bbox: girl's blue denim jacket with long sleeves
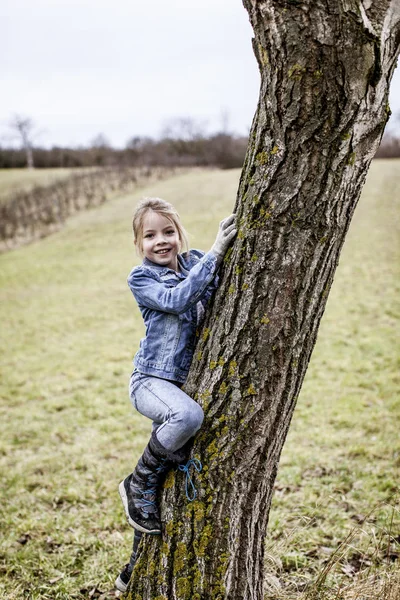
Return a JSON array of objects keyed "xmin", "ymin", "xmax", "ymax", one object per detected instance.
[{"xmin": 128, "ymin": 250, "xmax": 218, "ymax": 383}]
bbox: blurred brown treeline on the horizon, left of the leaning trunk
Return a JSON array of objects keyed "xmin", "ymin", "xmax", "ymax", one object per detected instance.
[{"xmin": 0, "ymin": 133, "xmax": 248, "ymax": 169}]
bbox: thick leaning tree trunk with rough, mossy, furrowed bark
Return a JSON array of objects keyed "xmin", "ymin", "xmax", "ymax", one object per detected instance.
[{"xmin": 129, "ymin": 0, "xmax": 400, "ymax": 600}]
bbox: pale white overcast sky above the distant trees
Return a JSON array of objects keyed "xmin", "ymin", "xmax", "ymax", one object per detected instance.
[{"xmin": 0, "ymin": 0, "xmax": 400, "ymax": 146}]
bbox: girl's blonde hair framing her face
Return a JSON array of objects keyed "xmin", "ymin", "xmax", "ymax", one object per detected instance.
[{"xmin": 132, "ymin": 198, "xmax": 189, "ymax": 256}]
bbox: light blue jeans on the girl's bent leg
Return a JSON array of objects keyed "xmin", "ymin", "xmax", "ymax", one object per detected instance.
[{"xmin": 129, "ymin": 371, "xmax": 204, "ymax": 452}]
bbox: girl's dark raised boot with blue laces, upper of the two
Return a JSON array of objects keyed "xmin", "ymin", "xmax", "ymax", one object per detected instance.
[{"xmin": 119, "ymin": 432, "xmax": 187, "ymax": 535}]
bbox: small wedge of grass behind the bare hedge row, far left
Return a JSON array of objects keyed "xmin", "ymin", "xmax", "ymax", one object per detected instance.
[{"xmin": 0, "ymin": 168, "xmax": 83, "ymax": 202}]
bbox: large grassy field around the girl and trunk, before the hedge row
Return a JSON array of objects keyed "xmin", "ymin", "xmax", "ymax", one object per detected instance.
[{"xmin": 0, "ymin": 160, "xmax": 400, "ymax": 600}]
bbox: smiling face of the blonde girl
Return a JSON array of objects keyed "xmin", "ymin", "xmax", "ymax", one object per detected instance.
[{"xmin": 142, "ymin": 210, "xmax": 181, "ymax": 271}]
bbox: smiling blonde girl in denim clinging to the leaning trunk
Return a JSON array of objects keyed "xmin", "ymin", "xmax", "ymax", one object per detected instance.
[{"xmin": 116, "ymin": 198, "xmax": 236, "ymax": 591}]
